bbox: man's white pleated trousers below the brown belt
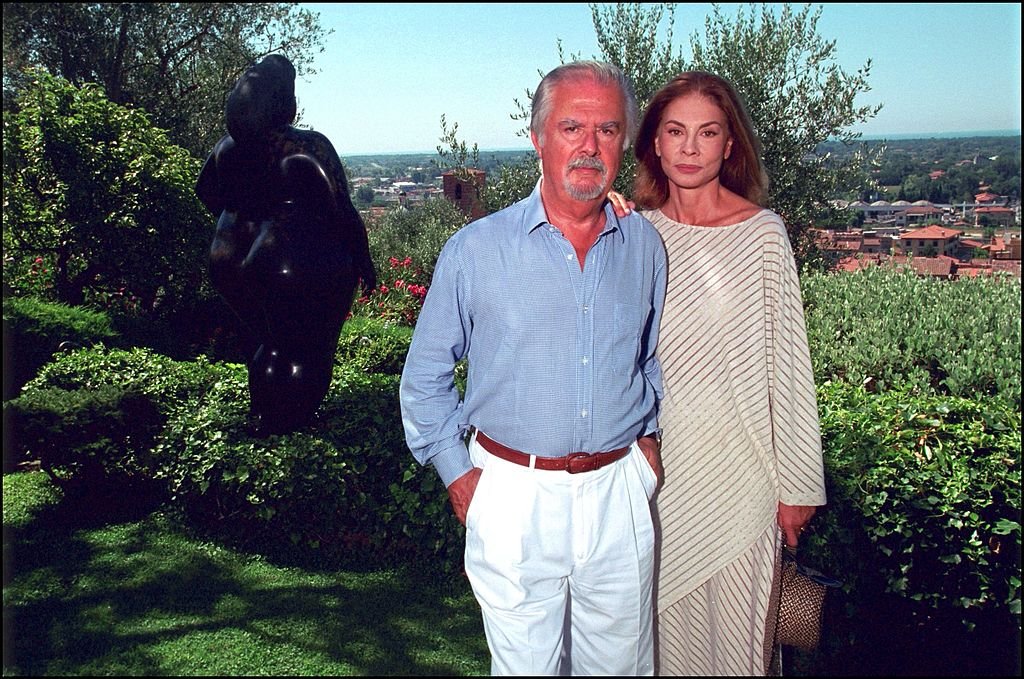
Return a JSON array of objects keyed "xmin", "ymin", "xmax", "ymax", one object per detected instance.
[{"xmin": 466, "ymin": 436, "xmax": 657, "ymax": 676}]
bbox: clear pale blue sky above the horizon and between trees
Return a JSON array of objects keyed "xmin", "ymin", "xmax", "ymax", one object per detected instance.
[{"xmin": 296, "ymin": 3, "xmax": 1021, "ymax": 157}]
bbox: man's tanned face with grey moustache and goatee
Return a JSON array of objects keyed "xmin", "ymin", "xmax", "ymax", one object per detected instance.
[{"xmin": 530, "ymin": 78, "xmax": 626, "ymax": 201}]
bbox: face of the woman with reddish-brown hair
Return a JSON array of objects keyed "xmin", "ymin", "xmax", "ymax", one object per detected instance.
[{"xmin": 654, "ymin": 93, "xmax": 732, "ymax": 188}]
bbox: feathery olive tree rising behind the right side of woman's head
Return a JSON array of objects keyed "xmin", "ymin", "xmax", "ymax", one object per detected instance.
[{"xmin": 687, "ymin": 4, "xmax": 882, "ymax": 260}]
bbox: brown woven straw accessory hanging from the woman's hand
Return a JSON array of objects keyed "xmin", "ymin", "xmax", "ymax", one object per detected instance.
[{"xmin": 775, "ymin": 545, "xmax": 842, "ymax": 650}]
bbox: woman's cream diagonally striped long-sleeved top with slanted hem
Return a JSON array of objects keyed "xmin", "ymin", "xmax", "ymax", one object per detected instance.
[{"xmin": 643, "ymin": 210, "xmax": 825, "ymax": 610}]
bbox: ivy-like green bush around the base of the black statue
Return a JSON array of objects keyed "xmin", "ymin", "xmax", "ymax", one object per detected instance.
[{"xmin": 14, "ymin": 348, "xmax": 463, "ymax": 572}]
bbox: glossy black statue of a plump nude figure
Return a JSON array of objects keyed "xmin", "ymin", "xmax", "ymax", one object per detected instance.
[{"xmin": 196, "ymin": 54, "xmax": 377, "ymax": 435}]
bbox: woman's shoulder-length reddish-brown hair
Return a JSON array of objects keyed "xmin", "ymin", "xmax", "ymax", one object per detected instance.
[{"xmin": 633, "ymin": 71, "xmax": 768, "ymax": 208}]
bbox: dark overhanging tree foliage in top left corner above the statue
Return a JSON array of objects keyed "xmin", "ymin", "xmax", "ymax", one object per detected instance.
[{"xmin": 3, "ymin": 2, "xmax": 325, "ymax": 158}]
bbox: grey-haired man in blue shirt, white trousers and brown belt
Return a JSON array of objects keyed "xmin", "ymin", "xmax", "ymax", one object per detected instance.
[{"xmin": 401, "ymin": 61, "xmax": 666, "ymax": 675}]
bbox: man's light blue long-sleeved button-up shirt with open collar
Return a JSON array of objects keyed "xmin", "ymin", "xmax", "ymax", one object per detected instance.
[{"xmin": 400, "ymin": 182, "xmax": 667, "ymax": 485}]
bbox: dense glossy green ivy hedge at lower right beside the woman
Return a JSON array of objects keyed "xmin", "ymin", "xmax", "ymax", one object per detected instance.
[{"xmin": 809, "ymin": 382, "xmax": 1021, "ymax": 628}]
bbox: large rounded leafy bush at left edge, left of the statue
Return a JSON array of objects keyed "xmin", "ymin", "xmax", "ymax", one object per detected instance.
[{"xmin": 3, "ymin": 66, "xmax": 210, "ymax": 312}]
